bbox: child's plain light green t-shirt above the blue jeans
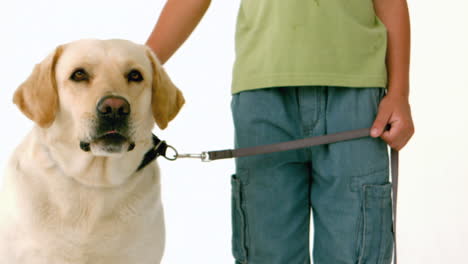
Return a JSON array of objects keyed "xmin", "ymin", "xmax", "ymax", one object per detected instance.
[{"xmin": 232, "ymin": 0, "xmax": 387, "ymax": 93}]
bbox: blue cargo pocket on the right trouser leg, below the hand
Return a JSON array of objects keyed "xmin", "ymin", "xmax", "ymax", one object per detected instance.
[{"xmin": 358, "ymin": 183, "xmax": 393, "ymax": 264}]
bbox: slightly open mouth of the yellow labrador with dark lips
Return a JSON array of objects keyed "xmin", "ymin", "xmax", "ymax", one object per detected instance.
[{"xmin": 80, "ymin": 130, "xmax": 135, "ymax": 156}]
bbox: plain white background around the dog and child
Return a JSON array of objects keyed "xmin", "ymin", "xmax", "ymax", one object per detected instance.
[{"xmin": 0, "ymin": 0, "xmax": 468, "ymax": 264}]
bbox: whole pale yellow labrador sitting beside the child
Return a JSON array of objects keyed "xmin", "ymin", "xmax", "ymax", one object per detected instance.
[{"xmin": 0, "ymin": 40, "xmax": 184, "ymax": 264}]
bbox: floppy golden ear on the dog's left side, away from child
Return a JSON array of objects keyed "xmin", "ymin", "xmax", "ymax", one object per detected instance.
[{"xmin": 13, "ymin": 46, "xmax": 62, "ymax": 127}]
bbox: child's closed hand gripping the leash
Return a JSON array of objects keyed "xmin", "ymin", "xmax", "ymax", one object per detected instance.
[{"xmin": 371, "ymin": 93, "xmax": 414, "ymax": 150}]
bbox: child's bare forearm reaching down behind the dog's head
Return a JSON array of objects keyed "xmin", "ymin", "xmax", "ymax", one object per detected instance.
[{"xmin": 146, "ymin": 0, "xmax": 211, "ymax": 64}]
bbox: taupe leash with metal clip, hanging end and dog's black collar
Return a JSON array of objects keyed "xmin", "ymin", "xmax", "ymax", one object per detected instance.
[{"xmin": 137, "ymin": 124, "xmax": 398, "ymax": 264}]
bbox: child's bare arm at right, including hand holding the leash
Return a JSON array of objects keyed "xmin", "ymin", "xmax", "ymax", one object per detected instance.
[{"xmin": 371, "ymin": 0, "xmax": 414, "ymax": 150}]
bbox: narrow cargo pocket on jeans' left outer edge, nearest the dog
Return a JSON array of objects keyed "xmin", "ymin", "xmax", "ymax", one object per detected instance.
[{"xmin": 231, "ymin": 174, "xmax": 247, "ymax": 264}]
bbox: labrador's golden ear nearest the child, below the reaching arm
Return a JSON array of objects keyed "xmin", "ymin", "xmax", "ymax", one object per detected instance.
[{"xmin": 146, "ymin": 47, "xmax": 185, "ymax": 129}]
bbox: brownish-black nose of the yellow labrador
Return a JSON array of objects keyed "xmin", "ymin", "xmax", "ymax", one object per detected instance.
[{"xmin": 96, "ymin": 95, "xmax": 130, "ymax": 118}]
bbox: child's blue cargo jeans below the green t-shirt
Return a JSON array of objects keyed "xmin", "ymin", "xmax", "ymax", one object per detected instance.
[{"xmin": 231, "ymin": 86, "xmax": 393, "ymax": 264}]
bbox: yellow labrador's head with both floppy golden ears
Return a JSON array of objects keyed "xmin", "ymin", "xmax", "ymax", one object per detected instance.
[{"xmin": 14, "ymin": 40, "xmax": 184, "ymax": 156}]
